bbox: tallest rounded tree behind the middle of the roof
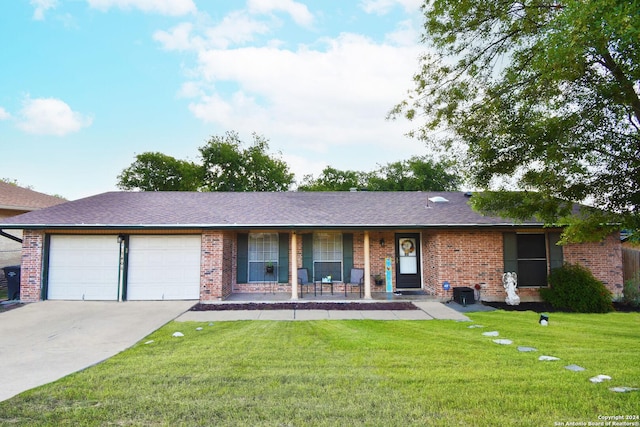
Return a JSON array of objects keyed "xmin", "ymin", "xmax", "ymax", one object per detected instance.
[{"xmin": 200, "ymin": 132, "xmax": 293, "ymax": 191}]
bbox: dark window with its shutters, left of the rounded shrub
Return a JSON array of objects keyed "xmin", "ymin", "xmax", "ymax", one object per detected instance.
[{"xmin": 504, "ymin": 233, "xmax": 563, "ymax": 287}]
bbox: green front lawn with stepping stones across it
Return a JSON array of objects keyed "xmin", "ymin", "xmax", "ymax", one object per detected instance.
[{"xmin": 0, "ymin": 311, "xmax": 640, "ymax": 426}]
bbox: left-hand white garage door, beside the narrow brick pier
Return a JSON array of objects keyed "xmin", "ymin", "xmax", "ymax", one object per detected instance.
[{"xmin": 47, "ymin": 235, "xmax": 120, "ymax": 301}]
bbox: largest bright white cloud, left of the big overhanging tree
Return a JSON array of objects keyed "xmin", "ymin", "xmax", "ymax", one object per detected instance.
[{"xmin": 190, "ymin": 34, "xmax": 420, "ymax": 159}]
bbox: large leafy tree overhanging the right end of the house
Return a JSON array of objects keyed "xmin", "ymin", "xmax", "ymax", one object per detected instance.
[{"xmin": 390, "ymin": 0, "xmax": 640, "ymax": 240}]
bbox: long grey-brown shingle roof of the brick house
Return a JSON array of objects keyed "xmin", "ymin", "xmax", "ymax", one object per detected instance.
[{"xmin": 0, "ymin": 191, "xmax": 542, "ymax": 228}]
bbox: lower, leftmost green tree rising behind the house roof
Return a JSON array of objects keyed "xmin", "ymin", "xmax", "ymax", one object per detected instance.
[{"xmin": 118, "ymin": 152, "xmax": 202, "ymax": 191}]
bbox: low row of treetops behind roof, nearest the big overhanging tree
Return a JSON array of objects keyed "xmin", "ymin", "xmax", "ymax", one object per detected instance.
[{"xmin": 298, "ymin": 156, "xmax": 460, "ymax": 191}]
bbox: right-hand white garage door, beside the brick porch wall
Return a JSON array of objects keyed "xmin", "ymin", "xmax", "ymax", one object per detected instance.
[{"xmin": 127, "ymin": 235, "xmax": 201, "ymax": 300}]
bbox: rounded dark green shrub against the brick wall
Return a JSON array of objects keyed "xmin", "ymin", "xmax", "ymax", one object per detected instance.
[{"xmin": 540, "ymin": 264, "xmax": 613, "ymax": 313}]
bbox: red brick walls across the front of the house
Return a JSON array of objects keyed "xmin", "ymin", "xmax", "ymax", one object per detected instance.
[{"xmin": 21, "ymin": 229, "xmax": 623, "ymax": 302}]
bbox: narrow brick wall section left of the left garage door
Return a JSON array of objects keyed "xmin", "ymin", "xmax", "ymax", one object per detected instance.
[{"xmin": 20, "ymin": 230, "xmax": 44, "ymax": 302}]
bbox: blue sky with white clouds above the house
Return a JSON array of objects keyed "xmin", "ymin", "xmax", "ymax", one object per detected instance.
[{"xmin": 0, "ymin": 0, "xmax": 427, "ymax": 200}]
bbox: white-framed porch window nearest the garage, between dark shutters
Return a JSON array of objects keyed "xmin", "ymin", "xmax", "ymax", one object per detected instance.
[{"xmin": 249, "ymin": 233, "xmax": 278, "ymax": 282}]
